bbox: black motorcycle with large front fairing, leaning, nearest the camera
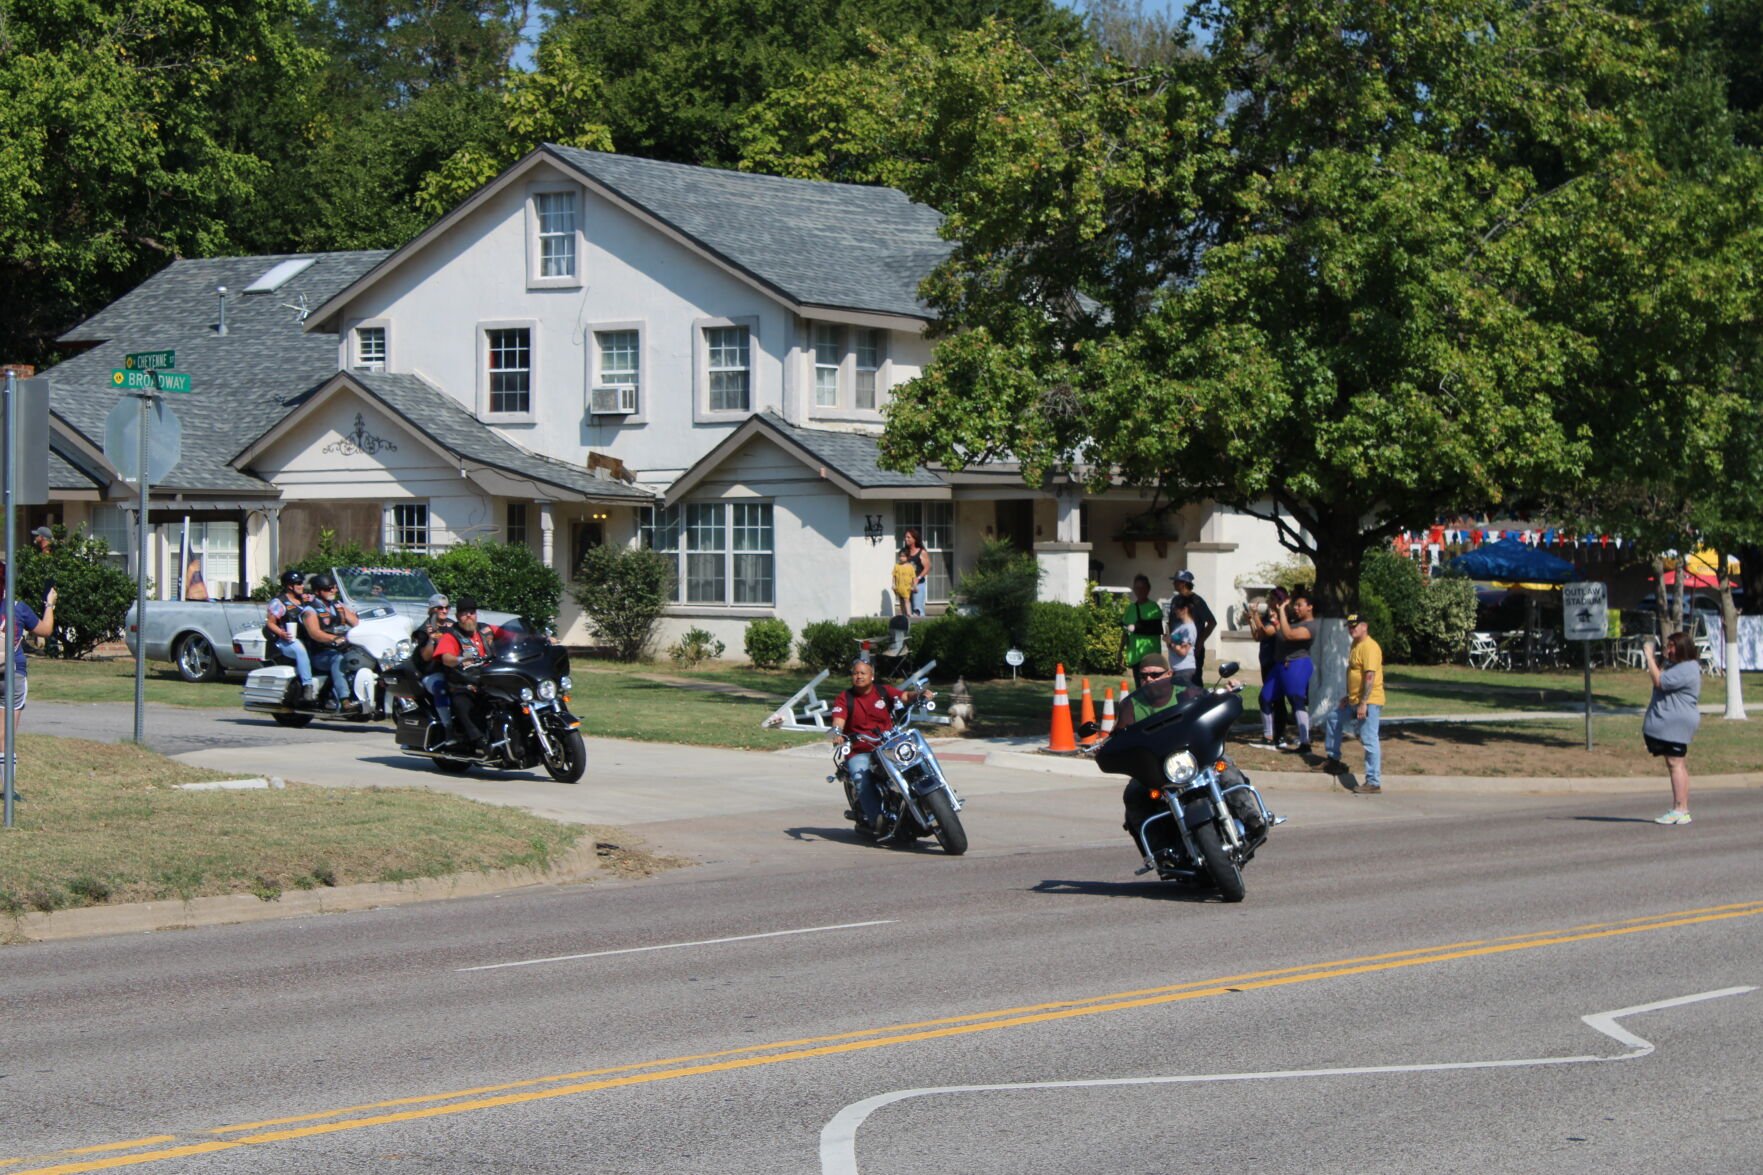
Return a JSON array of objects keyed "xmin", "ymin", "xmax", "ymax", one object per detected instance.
[{"xmin": 1082, "ymin": 662, "xmax": 1285, "ymax": 902}]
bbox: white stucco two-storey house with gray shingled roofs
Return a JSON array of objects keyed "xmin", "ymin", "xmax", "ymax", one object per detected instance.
[{"xmin": 34, "ymin": 146, "xmax": 1282, "ymax": 649}]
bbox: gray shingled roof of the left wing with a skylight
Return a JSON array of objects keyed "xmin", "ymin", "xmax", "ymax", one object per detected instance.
[{"xmin": 44, "ymin": 251, "xmax": 386, "ymax": 496}]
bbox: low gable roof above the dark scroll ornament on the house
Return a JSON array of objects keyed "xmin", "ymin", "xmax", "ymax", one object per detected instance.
[{"xmin": 233, "ymin": 370, "xmax": 656, "ymax": 505}]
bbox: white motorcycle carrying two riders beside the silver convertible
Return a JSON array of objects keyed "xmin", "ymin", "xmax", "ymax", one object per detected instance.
[{"xmin": 233, "ymin": 605, "xmax": 414, "ymax": 727}]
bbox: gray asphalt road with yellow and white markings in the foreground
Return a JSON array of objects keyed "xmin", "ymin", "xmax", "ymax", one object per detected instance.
[{"xmin": 0, "ymin": 709, "xmax": 1763, "ymax": 1175}]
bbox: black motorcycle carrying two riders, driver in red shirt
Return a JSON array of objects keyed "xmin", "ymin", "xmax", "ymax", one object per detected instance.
[{"xmin": 381, "ymin": 625, "xmax": 587, "ymax": 783}]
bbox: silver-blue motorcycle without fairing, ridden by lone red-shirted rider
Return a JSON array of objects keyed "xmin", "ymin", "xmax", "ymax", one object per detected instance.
[{"xmin": 816, "ymin": 662, "xmax": 968, "ymax": 857}]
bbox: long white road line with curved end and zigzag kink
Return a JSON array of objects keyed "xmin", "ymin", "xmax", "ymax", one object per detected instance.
[{"xmin": 820, "ymin": 986, "xmax": 1756, "ymax": 1175}]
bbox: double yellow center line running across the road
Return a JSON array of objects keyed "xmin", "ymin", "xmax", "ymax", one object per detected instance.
[{"xmin": 12, "ymin": 902, "xmax": 1763, "ymax": 1175}]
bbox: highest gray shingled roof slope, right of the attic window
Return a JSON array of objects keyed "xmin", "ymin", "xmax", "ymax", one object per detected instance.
[{"xmin": 545, "ymin": 145, "xmax": 952, "ymax": 318}]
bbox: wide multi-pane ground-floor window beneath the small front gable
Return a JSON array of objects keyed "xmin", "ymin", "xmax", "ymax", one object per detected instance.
[{"xmin": 636, "ymin": 501, "xmax": 777, "ymax": 607}]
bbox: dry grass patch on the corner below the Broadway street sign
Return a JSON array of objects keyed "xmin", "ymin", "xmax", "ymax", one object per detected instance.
[{"xmin": 0, "ymin": 734, "xmax": 587, "ymax": 916}]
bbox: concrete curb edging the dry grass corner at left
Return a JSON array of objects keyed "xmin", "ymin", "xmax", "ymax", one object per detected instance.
[{"xmin": 0, "ymin": 836, "xmax": 599, "ymax": 942}]
